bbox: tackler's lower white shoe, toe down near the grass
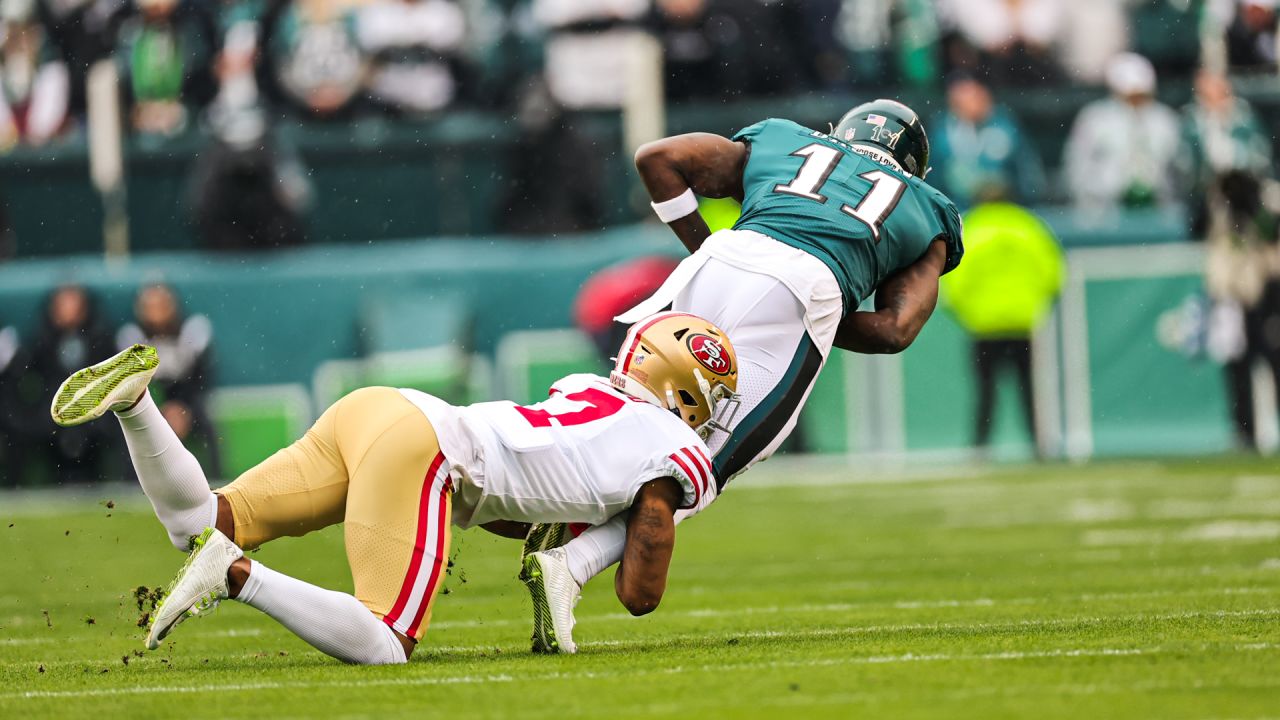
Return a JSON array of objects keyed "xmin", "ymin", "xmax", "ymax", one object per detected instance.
[{"xmin": 147, "ymin": 528, "xmax": 244, "ymax": 650}]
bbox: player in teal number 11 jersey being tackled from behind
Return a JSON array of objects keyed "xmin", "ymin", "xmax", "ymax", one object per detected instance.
[{"xmin": 526, "ymin": 100, "xmax": 964, "ymax": 652}]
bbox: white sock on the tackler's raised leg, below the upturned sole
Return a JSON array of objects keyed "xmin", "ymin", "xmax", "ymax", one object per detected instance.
[{"xmin": 116, "ymin": 391, "xmax": 218, "ymax": 552}]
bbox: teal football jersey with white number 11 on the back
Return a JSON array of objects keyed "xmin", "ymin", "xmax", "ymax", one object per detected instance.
[{"xmin": 733, "ymin": 119, "xmax": 964, "ymax": 314}]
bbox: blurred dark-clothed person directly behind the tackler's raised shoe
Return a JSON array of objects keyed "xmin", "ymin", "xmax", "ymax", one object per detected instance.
[{"xmin": 28, "ymin": 284, "xmax": 119, "ymax": 483}]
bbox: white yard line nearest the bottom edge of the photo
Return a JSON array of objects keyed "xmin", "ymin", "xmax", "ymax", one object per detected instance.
[{"xmin": 0, "ymin": 635, "xmax": 1280, "ymax": 700}]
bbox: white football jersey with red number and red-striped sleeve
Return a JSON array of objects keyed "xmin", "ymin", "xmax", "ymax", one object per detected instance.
[{"xmin": 401, "ymin": 374, "xmax": 717, "ymax": 528}]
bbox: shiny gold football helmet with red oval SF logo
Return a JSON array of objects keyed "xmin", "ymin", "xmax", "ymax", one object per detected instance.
[{"xmin": 609, "ymin": 313, "xmax": 739, "ymax": 439}]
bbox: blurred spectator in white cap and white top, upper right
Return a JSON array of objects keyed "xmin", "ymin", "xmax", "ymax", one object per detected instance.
[{"xmin": 1064, "ymin": 53, "xmax": 1183, "ymax": 209}]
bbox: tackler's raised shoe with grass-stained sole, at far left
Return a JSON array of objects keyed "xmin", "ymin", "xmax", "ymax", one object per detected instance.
[{"xmin": 49, "ymin": 345, "xmax": 160, "ymax": 428}]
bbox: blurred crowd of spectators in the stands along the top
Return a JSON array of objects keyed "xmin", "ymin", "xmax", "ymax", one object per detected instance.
[{"xmin": 0, "ymin": 0, "xmax": 1277, "ymax": 243}]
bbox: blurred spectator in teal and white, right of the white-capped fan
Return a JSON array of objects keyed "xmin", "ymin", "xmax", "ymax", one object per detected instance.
[{"xmin": 1183, "ymin": 70, "xmax": 1271, "ymax": 230}]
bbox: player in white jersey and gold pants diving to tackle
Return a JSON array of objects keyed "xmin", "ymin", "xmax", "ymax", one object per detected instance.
[{"xmin": 51, "ymin": 313, "xmax": 737, "ymax": 664}]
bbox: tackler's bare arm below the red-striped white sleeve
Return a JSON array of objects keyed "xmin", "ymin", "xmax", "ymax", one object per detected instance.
[{"xmin": 613, "ymin": 478, "xmax": 684, "ymax": 615}]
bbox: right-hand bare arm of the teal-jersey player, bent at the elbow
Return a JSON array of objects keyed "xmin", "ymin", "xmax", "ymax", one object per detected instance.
[{"xmin": 836, "ymin": 240, "xmax": 947, "ymax": 354}]
